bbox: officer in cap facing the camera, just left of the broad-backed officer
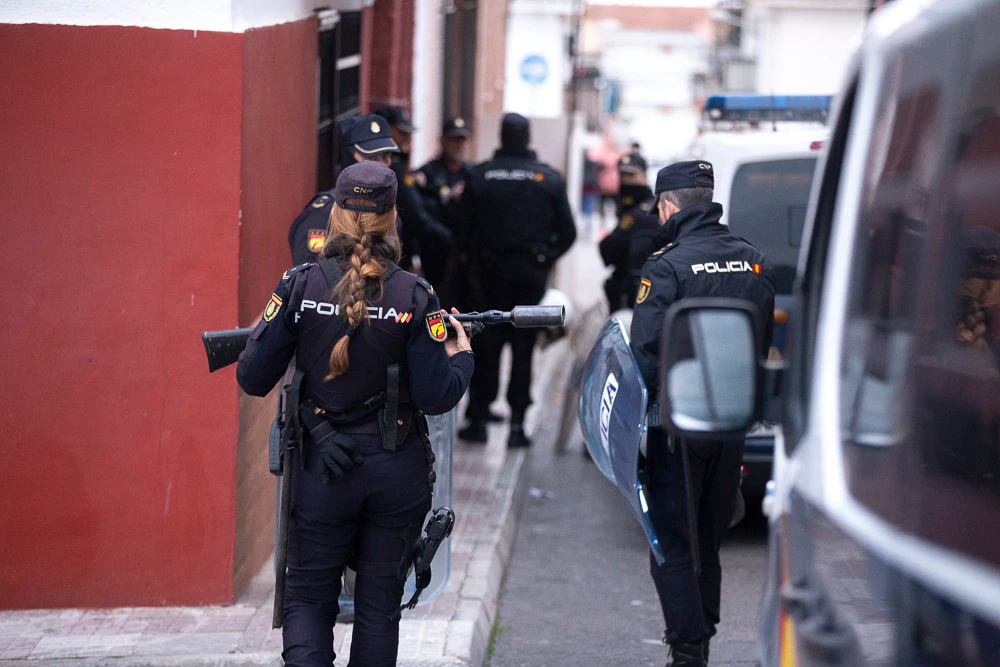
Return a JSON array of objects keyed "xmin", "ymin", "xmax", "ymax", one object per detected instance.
[{"xmin": 411, "ymin": 118, "xmax": 472, "ymax": 309}]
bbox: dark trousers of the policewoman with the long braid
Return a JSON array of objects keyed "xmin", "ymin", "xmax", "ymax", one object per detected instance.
[{"xmin": 281, "ymin": 434, "xmax": 431, "ymax": 667}]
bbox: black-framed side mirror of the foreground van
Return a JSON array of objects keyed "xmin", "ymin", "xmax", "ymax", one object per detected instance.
[{"xmin": 659, "ymin": 298, "xmax": 761, "ymax": 437}]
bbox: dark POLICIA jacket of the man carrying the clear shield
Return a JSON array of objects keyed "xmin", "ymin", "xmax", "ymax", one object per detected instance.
[{"xmin": 631, "ymin": 203, "xmax": 774, "ymax": 394}]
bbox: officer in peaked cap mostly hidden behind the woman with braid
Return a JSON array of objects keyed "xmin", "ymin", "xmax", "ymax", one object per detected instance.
[{"xmin": 288, "ymin": 114, "xmax": 399, "ymax": 265}]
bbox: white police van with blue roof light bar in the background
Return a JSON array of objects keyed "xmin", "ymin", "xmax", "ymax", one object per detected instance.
[{"xmin": 689, "ymin": 95, "xmax": 831, "ymax": 498}]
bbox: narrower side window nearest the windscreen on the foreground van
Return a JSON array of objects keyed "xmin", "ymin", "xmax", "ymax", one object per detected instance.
[{"xmin": 840, "ymin": 46, "xmax": 948, "ymax": 523}]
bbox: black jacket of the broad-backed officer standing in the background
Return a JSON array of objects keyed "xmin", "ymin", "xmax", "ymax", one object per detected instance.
[{"xmin": 461, "ymin": 148, "xmax": 576, "ymax": 266}]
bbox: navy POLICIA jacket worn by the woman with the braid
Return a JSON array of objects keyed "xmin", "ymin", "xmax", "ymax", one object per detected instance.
[{"xmin": 236, "ymin": 264, "xmax": 473, "ymax": 414}]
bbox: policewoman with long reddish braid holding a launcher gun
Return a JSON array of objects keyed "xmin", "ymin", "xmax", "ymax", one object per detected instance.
[{"xmin": 236, "ymin": 162, "xmax": 473, "ymax": 666}]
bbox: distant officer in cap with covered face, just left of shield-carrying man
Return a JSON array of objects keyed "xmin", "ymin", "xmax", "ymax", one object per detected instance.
[{"xmin": 598, "ymin": 153, "xmax": 660, "ymax": 312}]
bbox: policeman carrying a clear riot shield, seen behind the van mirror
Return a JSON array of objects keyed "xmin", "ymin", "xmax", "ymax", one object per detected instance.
[{"xmin": 631, "ymin": 160, "xmax": 775, "ymax": 667}]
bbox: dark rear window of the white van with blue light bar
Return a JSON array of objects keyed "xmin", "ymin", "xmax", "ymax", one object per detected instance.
[{"xmin": 729, "ymin": 157, "xmax": 816, "ymax": 294}]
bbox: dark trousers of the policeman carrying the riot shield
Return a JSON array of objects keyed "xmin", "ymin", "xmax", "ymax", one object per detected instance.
[{"xmin": 647, "ymin": 429, "xmax": 744, "ymax": 644}]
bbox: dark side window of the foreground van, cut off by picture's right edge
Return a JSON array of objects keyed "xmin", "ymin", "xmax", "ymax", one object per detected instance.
[{"xmin": 906, "ymin": 39, "xmax": 1000, "ymax": 566}]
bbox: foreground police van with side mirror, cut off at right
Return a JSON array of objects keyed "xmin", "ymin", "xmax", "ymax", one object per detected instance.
[{"xmin": 660, "ymin": 0, "xmax": 1000, "ymax": 666}]
